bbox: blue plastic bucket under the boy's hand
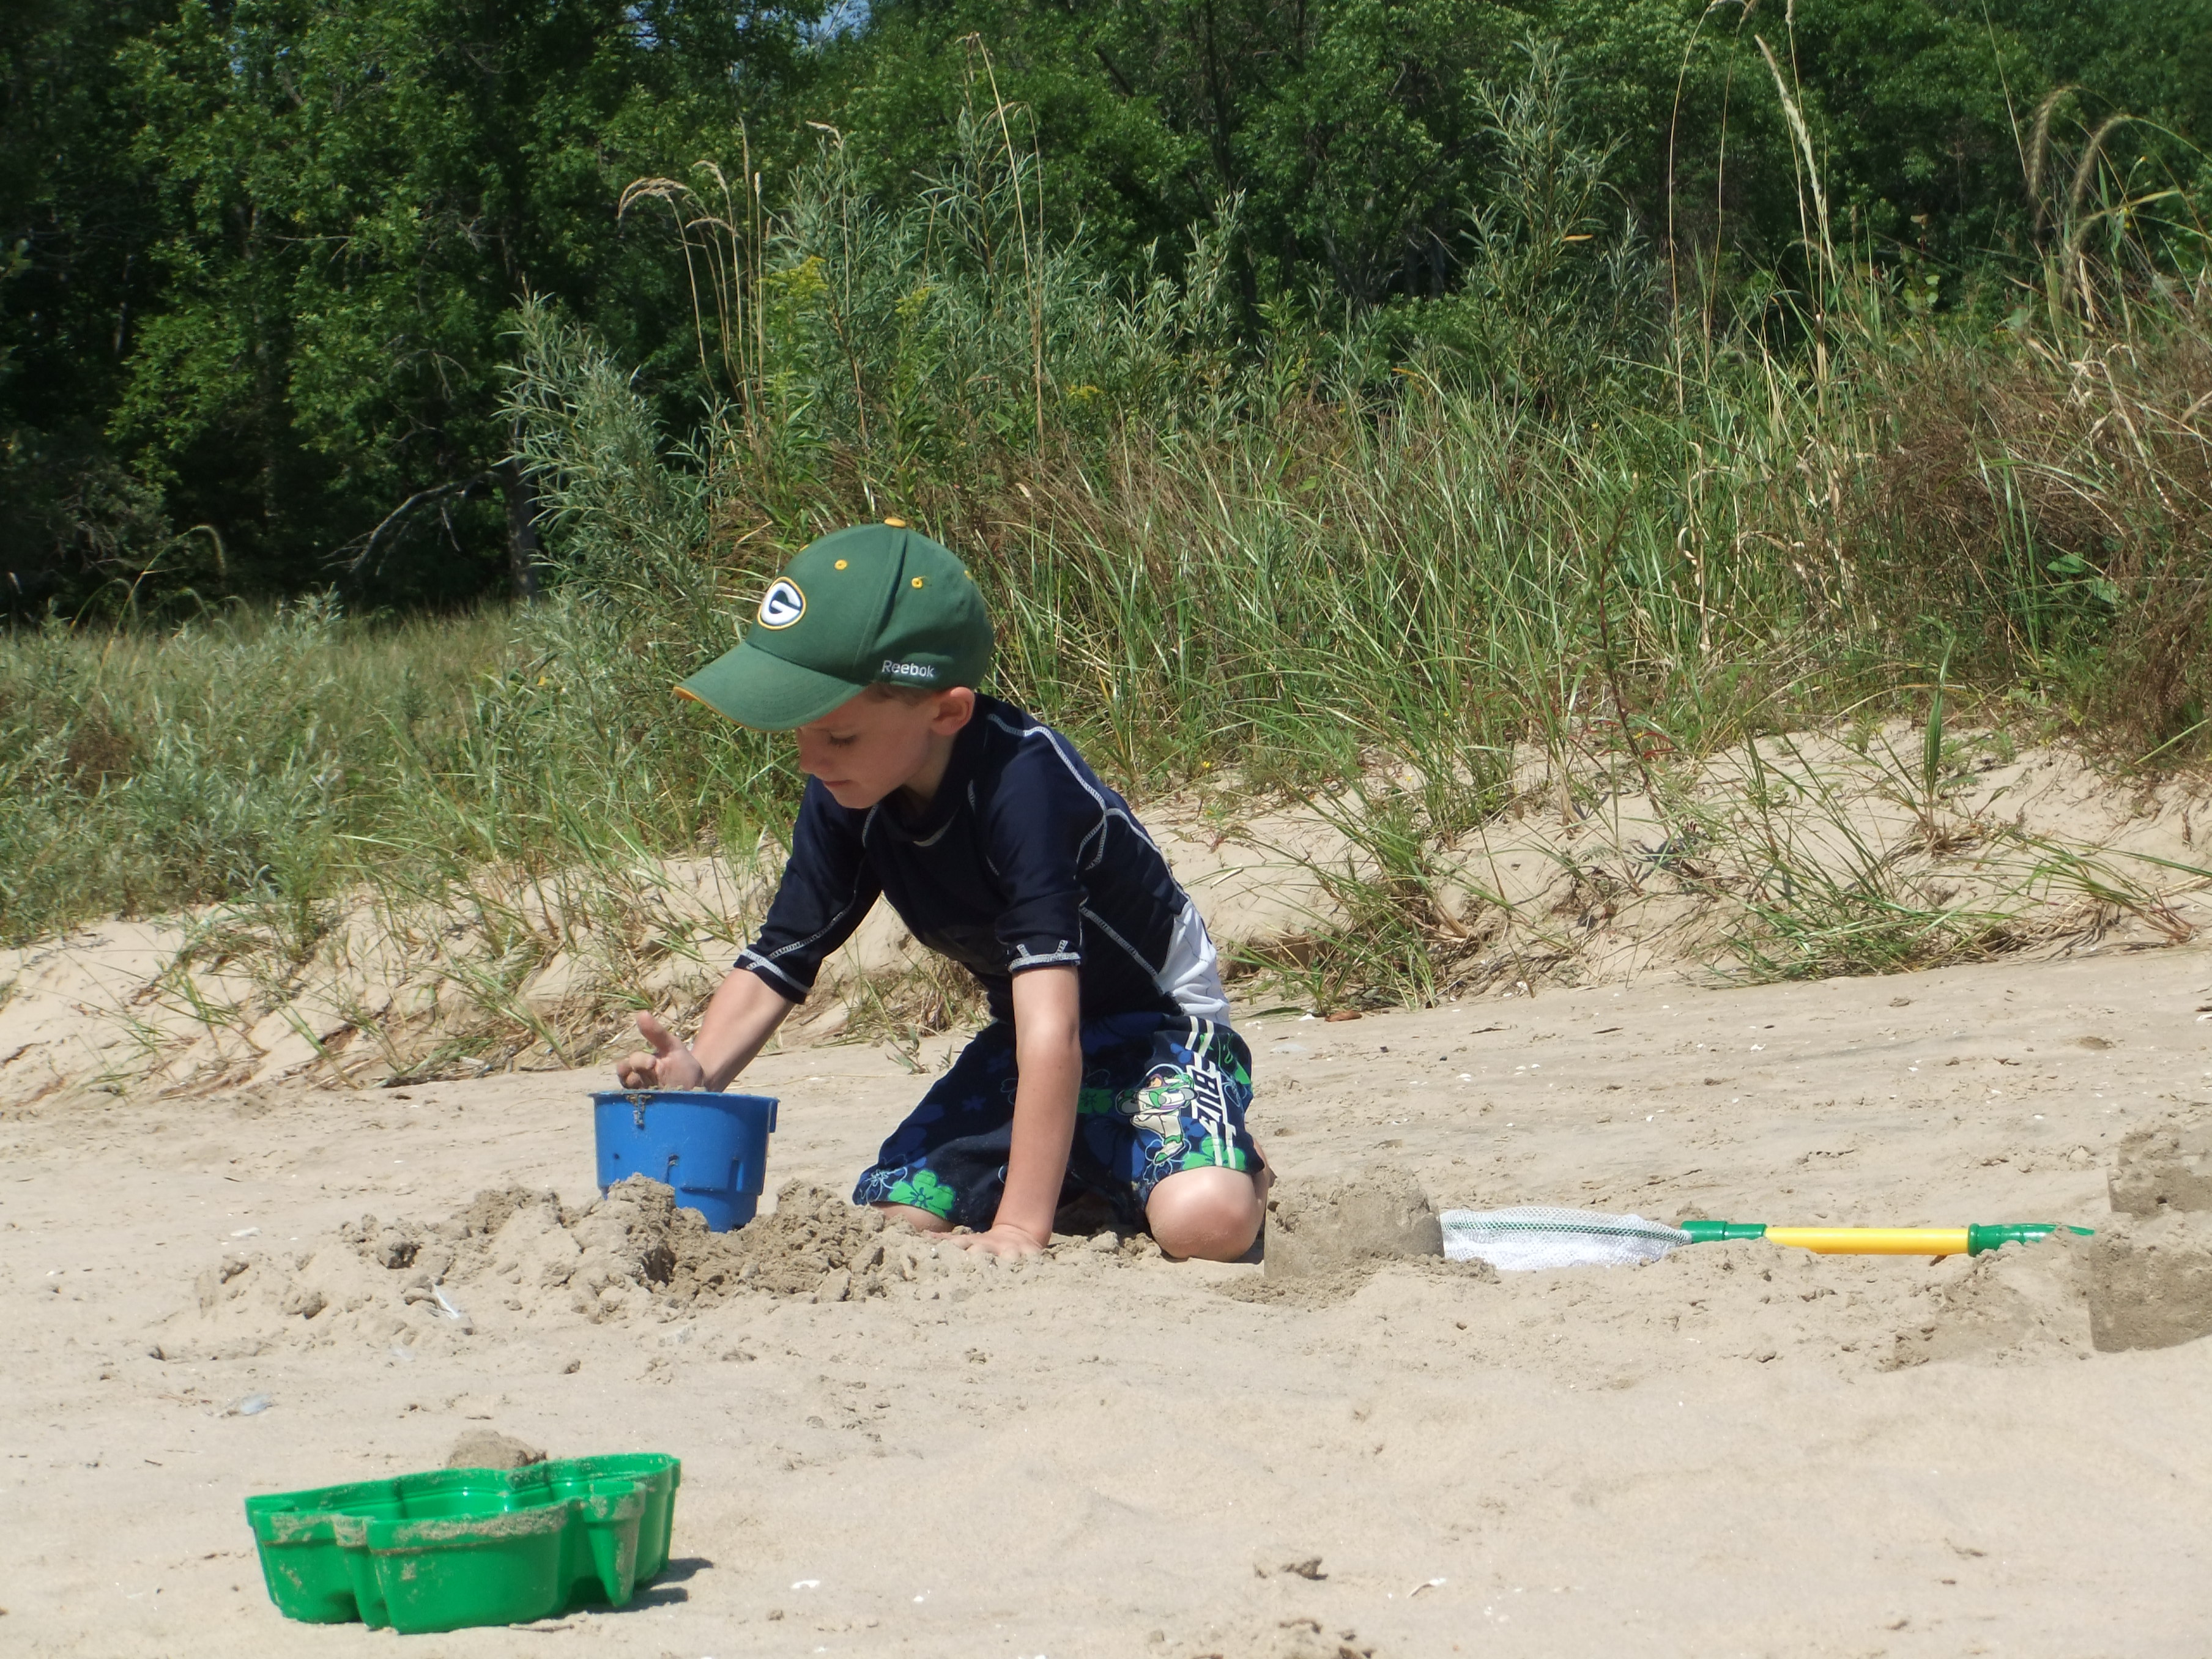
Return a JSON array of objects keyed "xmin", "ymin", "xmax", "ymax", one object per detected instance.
[{"xmin": 590, "ymin": 1088, "xmax": 776, "ymax": 1232}]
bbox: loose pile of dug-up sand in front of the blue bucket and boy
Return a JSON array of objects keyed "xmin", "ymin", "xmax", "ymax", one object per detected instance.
[{"xmin": 157, "ymin": 1175, "xmax": 1159, "ymax": 1358}]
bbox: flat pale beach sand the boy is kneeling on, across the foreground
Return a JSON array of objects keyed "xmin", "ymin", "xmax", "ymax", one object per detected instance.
[{"xmin": 0, "ymin": 949, "xmax": 2212, "ymax": 1659}]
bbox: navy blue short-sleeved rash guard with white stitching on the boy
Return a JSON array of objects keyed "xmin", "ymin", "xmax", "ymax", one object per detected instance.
[{"xmin": 737, "ymin": 697, "xmax": 1228, "ymax": 1024}]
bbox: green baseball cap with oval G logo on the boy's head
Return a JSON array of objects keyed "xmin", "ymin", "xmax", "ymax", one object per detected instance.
[{"xmin": 677, "ymin": 520, "xmax": 991, "ymax": 732}]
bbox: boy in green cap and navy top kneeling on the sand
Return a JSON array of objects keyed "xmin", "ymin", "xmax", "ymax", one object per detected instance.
[{"xmin": 617, "ymin": 520, "xmax": 1267, "ymax": 1261}]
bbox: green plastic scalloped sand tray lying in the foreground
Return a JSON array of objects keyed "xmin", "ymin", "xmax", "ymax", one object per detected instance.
[{"xmin": 245, "ymin": 1451, "xmax": 683, "ymax": 1635}]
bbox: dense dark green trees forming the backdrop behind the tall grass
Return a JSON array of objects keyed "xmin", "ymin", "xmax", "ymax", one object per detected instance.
[{"xmin": 0, "ymin": 0, "xmax": 2212, "ymax": 619}]
